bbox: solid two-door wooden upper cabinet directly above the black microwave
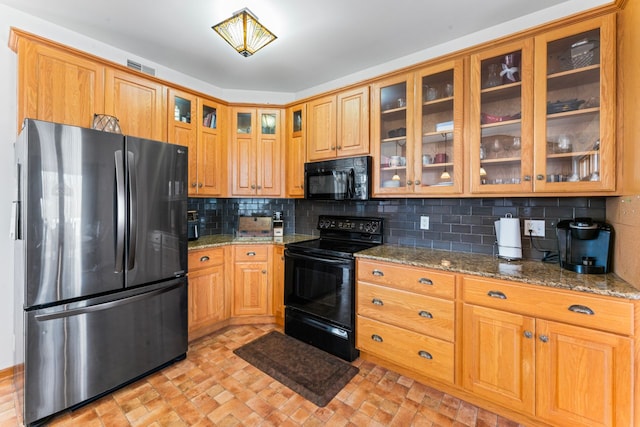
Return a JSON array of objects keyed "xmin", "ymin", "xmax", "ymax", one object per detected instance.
[{"xmin": 307, "ymin": 86, "xmax": 369, "ymax": 161}]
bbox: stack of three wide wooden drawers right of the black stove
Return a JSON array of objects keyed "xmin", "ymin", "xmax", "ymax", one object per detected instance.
[{"xmin": 356, "ymin": 260, "xmax": 456, "ymax": 384}]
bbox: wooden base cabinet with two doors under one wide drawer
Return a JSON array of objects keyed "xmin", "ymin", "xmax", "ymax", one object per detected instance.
[{"xmin": 462, "ymin": 277, "xmax": 633, "ymax": 426}]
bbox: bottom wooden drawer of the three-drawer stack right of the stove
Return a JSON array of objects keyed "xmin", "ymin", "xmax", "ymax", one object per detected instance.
[{"xmin": 356, "ymin": 316, "xmax": 454, "ymax": 383}]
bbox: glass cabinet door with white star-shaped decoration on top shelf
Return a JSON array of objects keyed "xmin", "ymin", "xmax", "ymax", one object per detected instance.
[{"xmin": 469, "ymin": 39, "xmax": 534, "ymax": 193}]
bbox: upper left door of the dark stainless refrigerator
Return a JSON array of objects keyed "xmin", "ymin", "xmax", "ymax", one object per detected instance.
[{"xmin": 15, "ymin": 120, "xmax": 126, "ymax": 307}]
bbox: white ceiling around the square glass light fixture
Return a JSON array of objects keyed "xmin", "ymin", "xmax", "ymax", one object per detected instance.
[{"xmin": 0, "ymin": 0, "xmax": 608, "ymax": 93}]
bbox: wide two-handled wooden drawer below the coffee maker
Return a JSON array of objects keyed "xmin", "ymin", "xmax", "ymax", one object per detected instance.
[{"xmin": 462, "ymin": 276, "xmax": 634, "ymax": 335}]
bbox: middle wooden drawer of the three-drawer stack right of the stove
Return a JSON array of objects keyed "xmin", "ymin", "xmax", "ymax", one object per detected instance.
[{"xmin": 356, "ymin": 282, "xmax": 455, "ymax": 341}]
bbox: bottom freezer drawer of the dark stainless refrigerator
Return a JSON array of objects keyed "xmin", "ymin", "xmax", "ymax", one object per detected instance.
[{"xmin": 18, "ymin": 278, "xmax": 187, "ymax": 425}]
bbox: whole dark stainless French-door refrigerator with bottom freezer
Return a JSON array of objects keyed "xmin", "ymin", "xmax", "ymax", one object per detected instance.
[{"xmin": 12, "ymin": 120, "xmax": 188, "ymax": 425}]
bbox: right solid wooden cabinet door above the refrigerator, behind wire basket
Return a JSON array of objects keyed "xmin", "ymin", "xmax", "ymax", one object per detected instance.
[{"xmin": 104, "ymin": 68, "xmax": 167, "ymax": 141}]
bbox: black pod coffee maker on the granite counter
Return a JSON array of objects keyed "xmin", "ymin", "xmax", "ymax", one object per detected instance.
[{"xmin": 556, "ymin": 218, "xmax": 613, "ymax": 274}]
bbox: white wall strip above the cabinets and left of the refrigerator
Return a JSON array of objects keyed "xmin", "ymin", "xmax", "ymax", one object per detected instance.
[{"xmin": 0, "ymin": 0, "xmax": 609, "ymax": 370}]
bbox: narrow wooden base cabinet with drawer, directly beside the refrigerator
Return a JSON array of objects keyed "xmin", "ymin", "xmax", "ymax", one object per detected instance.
[{"xmin": 188, "ymin": 248, "xmax": 229, "ymax": 341}]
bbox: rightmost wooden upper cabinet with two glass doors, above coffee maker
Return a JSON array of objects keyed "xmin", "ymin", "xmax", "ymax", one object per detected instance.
[{"xmin": 469, "ymin": 16, "xmax": 616, "ymax": 193}]
